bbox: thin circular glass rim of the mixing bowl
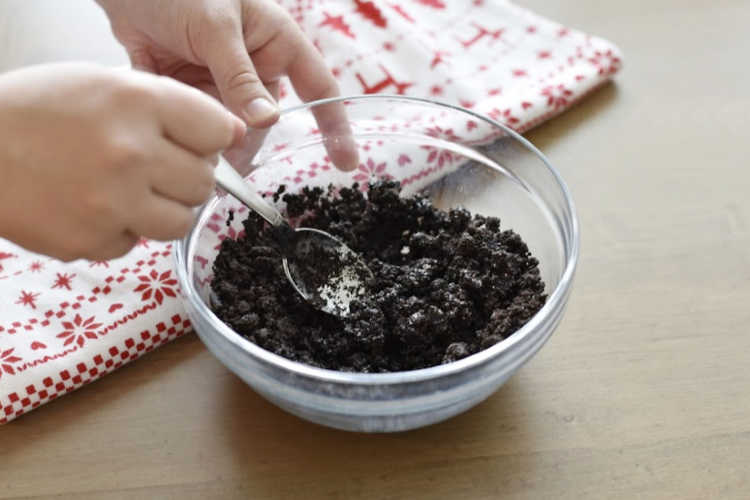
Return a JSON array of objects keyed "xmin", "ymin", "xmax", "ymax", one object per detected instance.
[{"xmin": 173, "ymin": 94, "xmax": 580, "ymax": 386}]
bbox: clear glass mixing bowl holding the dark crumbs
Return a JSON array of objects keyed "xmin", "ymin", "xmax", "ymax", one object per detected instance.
[{"xmin": 175, "ymin": 95, "xmax": 579, "ymax": 432}]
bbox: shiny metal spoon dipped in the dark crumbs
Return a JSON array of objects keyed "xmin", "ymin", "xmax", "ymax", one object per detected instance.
[{"xmin": 214, "ymin": 155, "xmax": 372, "ymax": 317}]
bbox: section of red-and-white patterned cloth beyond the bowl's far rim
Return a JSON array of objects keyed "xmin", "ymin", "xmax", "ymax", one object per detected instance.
[{"xmin": 280, "ymin": 0, "xmax": 622, "ymax": 132}]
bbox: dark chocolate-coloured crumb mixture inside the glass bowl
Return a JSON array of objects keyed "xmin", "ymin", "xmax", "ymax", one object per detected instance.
[{"xmin": 211, "ymin": 181, "xmax": 546, "ymax": 372}]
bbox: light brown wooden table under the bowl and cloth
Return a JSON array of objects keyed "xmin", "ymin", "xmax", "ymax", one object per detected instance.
[{"xmin": 0, "ymin": 0, "xmax": 750, "ymax": 499}]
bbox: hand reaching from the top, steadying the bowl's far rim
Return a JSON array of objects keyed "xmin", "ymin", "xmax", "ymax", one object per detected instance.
[{"xmin": 98, "ymin": 0, "xmax": 358, "ymax": 170}]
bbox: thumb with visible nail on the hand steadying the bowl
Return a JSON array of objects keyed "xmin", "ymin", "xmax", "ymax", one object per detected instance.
[{"xmin": 203, "ymin": 30, "xmax": 279, "ymax": 128}]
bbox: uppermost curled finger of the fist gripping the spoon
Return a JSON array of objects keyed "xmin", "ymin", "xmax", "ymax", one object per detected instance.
[{"xmin": 153, "ymin": 78, "xmax": 246, "ymax": 156}]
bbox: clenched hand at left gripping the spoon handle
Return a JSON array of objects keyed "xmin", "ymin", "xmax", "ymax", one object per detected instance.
[{"xmin": 0, "ymin": 64, "xmax": 245, "ymax": 260}]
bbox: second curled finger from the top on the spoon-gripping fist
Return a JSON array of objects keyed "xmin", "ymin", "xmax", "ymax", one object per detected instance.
[{"xmin": 149, "ymin": 140, "xmax": 215, "ymax": 206}]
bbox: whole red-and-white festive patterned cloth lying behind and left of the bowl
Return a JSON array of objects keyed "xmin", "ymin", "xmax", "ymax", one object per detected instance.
[{"xmin": 0, "ymin": 0, "xmax": 621, "ymax": 423}]
